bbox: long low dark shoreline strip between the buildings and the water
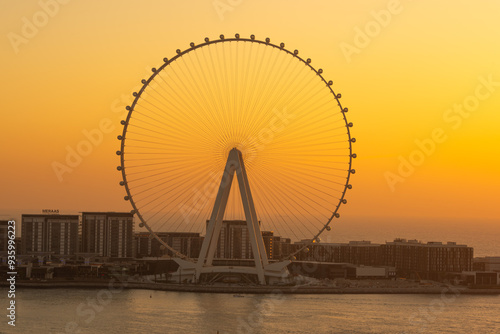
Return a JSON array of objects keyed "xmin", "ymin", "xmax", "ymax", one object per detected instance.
[{"xmin": 0, "ymin": 281, "xmax": 500, "ymax": 295}]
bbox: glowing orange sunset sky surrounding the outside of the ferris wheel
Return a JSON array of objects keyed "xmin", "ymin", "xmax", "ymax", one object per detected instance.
[{"xmin": 0, "ymin": 0, "xmax": 500, "ymax": 240}]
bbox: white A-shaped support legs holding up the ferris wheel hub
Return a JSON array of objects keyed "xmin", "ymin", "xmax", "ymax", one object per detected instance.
[{"xmin": 195, "ymin": 148, "xmax": 269, "ymax": 285}]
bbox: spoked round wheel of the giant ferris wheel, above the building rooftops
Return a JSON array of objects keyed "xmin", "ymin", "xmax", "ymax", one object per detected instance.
[{"xmin": 117, "ymin": 34, "xmax": 356, "ymax": 264}]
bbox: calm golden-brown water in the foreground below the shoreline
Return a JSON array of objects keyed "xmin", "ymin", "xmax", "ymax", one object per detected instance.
[{"xmin": 0, "ymin": 289, "xmax": 500, "ymax": 334}]
